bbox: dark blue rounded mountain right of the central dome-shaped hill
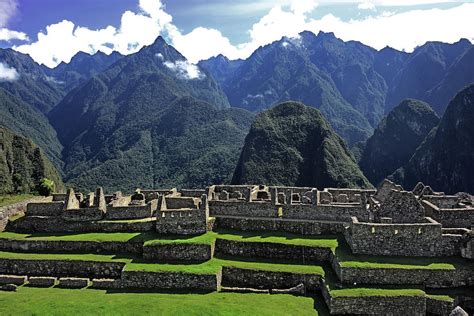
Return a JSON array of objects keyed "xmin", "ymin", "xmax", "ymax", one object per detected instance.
[{"xmin": 359, "ymin": 99, "xmax": 439, "ymax": 185}]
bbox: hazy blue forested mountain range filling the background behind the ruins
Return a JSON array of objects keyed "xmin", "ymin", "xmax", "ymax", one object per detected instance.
[{"xmin": 0, "ymin": 32, "xmax": 474, "ymax": 191}]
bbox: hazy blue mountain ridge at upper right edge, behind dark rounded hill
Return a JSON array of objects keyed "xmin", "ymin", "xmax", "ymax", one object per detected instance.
[{"xmin": 386, "ymin": 39, "xmax": 474, "ymax": 114}]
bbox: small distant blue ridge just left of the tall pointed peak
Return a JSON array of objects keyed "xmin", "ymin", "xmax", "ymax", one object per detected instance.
[{"xmin": 44, "ymin": 51, "xmax": 123, "ymax": 92}]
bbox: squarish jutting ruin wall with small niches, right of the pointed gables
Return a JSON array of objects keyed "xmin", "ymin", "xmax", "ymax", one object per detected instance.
[{"xmin": 156, "ymin": 209, "xmax": 207, "ymax": 235}]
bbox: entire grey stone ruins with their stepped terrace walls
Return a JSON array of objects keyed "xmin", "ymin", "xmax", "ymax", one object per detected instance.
[{"xmin": 0, "ymin": 180, "xmax": 474, "ymax": 315}]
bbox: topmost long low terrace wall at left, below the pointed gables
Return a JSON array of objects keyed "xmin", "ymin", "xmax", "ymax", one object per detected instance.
[{"xmin": 9, "ymin": 216, "xmax": 155, "ymax": 233}]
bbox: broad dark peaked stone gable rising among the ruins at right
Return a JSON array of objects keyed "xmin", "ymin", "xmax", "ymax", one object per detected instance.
[{"xmin": 378, "ymin": 190, "xmax": 425, "ymax": 223}]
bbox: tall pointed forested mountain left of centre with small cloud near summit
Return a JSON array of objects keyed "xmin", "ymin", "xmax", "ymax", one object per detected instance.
[{"xmin": 49, "ymin": 37, "xmax": 253, "ymax": 191}]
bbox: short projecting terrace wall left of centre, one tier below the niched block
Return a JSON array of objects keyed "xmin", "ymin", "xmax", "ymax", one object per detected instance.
[{"xmin": 143, "ymin": 243, "xmax": 214, "ymax": 262}]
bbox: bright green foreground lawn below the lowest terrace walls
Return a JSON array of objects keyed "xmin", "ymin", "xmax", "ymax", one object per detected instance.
[{"xmin": 0, "ymin": 287, "xmax": 317, "ymax": 316}]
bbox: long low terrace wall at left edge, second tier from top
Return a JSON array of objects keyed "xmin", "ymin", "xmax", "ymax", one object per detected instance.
[{"xmin": 0, "ymin": 238, "xmax": 143, "ymax": 254}]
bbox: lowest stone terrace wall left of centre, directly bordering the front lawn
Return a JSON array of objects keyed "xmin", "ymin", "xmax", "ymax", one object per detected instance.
[{"xmin": 121, "ymin": 271, "xmax": 221, "ymax": 291}]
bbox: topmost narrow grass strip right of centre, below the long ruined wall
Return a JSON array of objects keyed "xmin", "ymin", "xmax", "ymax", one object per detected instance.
[{"xmin": 217, "ymin": 231, "xmax": 338, "ymax": 250}]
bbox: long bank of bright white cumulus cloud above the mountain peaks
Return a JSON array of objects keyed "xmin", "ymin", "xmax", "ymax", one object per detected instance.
[{"xmin": 6, "ymin": 0, "xmax": 474, "ymax": 66}]
